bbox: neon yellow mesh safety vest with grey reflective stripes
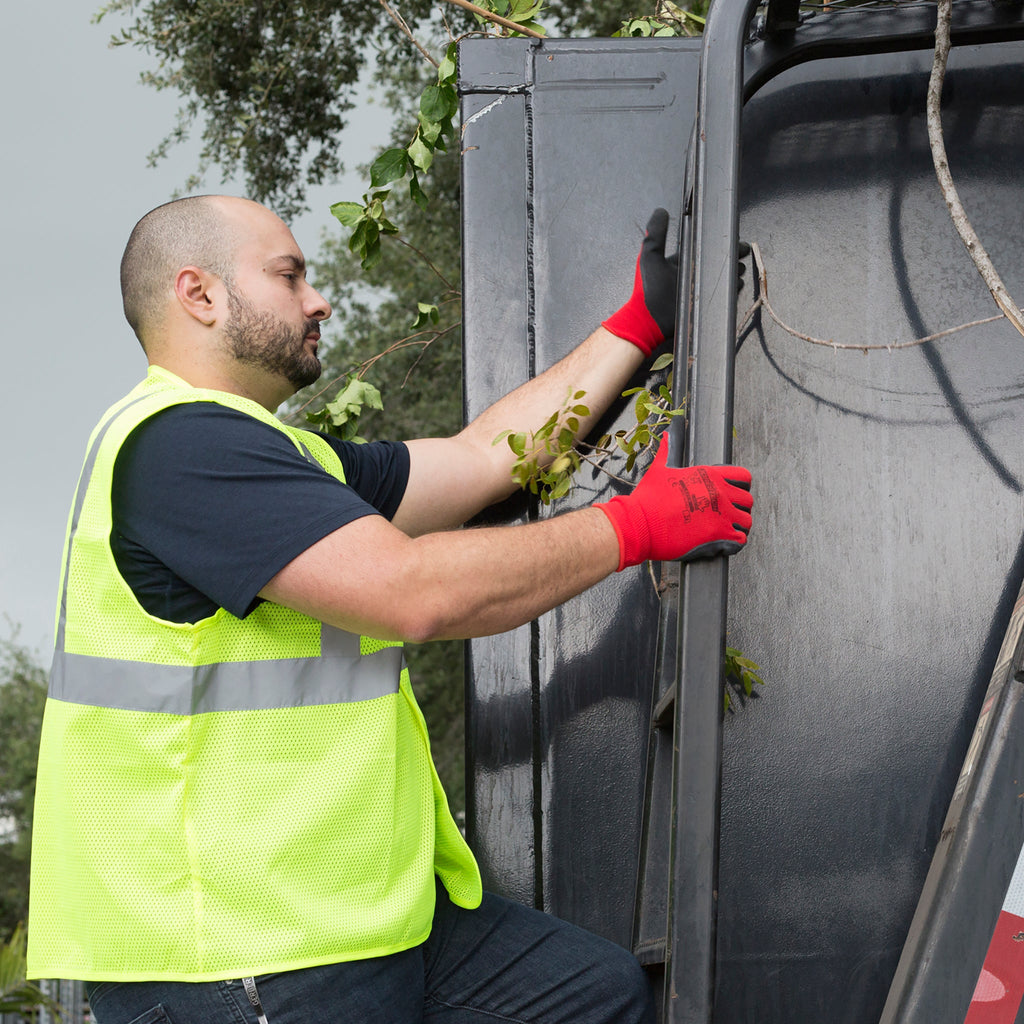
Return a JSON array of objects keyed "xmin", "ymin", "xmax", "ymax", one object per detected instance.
[{"xmin": 28, "ymin": 368, "xmax": 481, "ymax": 981}]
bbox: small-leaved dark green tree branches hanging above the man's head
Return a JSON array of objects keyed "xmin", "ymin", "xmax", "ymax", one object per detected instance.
[{"xmin": 96, "ymin": 0, "xmax": 452, "ymax": 217}]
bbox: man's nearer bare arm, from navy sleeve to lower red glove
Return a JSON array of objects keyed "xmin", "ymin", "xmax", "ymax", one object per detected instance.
[{"xmin": 261, "ymin": 508, "xmax": 618, "ymax": 642}]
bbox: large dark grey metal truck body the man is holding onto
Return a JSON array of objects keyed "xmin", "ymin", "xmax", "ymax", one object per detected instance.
[{"xmin": 460, "ymin": 0, "xmax": 1024, "ymax": 1024}]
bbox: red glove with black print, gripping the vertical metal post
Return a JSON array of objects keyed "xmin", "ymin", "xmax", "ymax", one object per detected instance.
[{"xmin": 594, "ymin": 443, "xmax": 754, "ymax": 570}]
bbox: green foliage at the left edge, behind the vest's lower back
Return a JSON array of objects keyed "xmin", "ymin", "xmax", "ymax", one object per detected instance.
[{"xmin": 0, "ymin": 640, "xmax": 46, "ymax": 935}]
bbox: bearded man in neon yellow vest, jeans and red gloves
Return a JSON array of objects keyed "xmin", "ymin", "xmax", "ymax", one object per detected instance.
[{"xmin": 29, "ymin": 197, "xmax": 751, "ymax": 1024}]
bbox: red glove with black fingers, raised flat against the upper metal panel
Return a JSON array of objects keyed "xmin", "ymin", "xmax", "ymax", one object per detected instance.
[{"xmin": 602, "ymin": 208, "xmax": 679, "ymax": 355}]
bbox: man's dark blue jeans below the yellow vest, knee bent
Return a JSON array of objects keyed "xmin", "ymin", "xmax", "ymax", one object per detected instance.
[{"xmin": 86, "ymin": 885, "xmax": 654, "ymax": 1024}]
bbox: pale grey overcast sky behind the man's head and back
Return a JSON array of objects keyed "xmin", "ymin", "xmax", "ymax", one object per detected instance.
[{"xmin": 0, "ymin": 0, "xmax": 387, "ymax": 665}]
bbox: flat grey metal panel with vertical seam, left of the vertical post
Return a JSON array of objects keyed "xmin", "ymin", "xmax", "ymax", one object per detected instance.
[{"xmin": 460, "ymin": 34, "xmax": 699, "ymax": 944}]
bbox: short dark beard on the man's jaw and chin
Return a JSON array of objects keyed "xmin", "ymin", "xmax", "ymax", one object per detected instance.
[{"xmin": 224, "ymin": 283, "xmax": 322, "ymax": 391}]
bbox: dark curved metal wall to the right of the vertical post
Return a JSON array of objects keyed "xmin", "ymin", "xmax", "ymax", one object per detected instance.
[{"xmin": 718, "ymin": 44, "xmax": 1024, "ymax": 1022}]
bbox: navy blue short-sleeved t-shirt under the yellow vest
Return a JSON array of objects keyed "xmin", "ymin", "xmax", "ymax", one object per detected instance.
[{"xmin": 111, "ymin": 402, "xmax": 409, "ymax": 623}]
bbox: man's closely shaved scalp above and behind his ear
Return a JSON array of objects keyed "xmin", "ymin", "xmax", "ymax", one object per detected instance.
[{"xmin": 121, "ymin": 196, "xmax": 247, "ymax": 349}]
